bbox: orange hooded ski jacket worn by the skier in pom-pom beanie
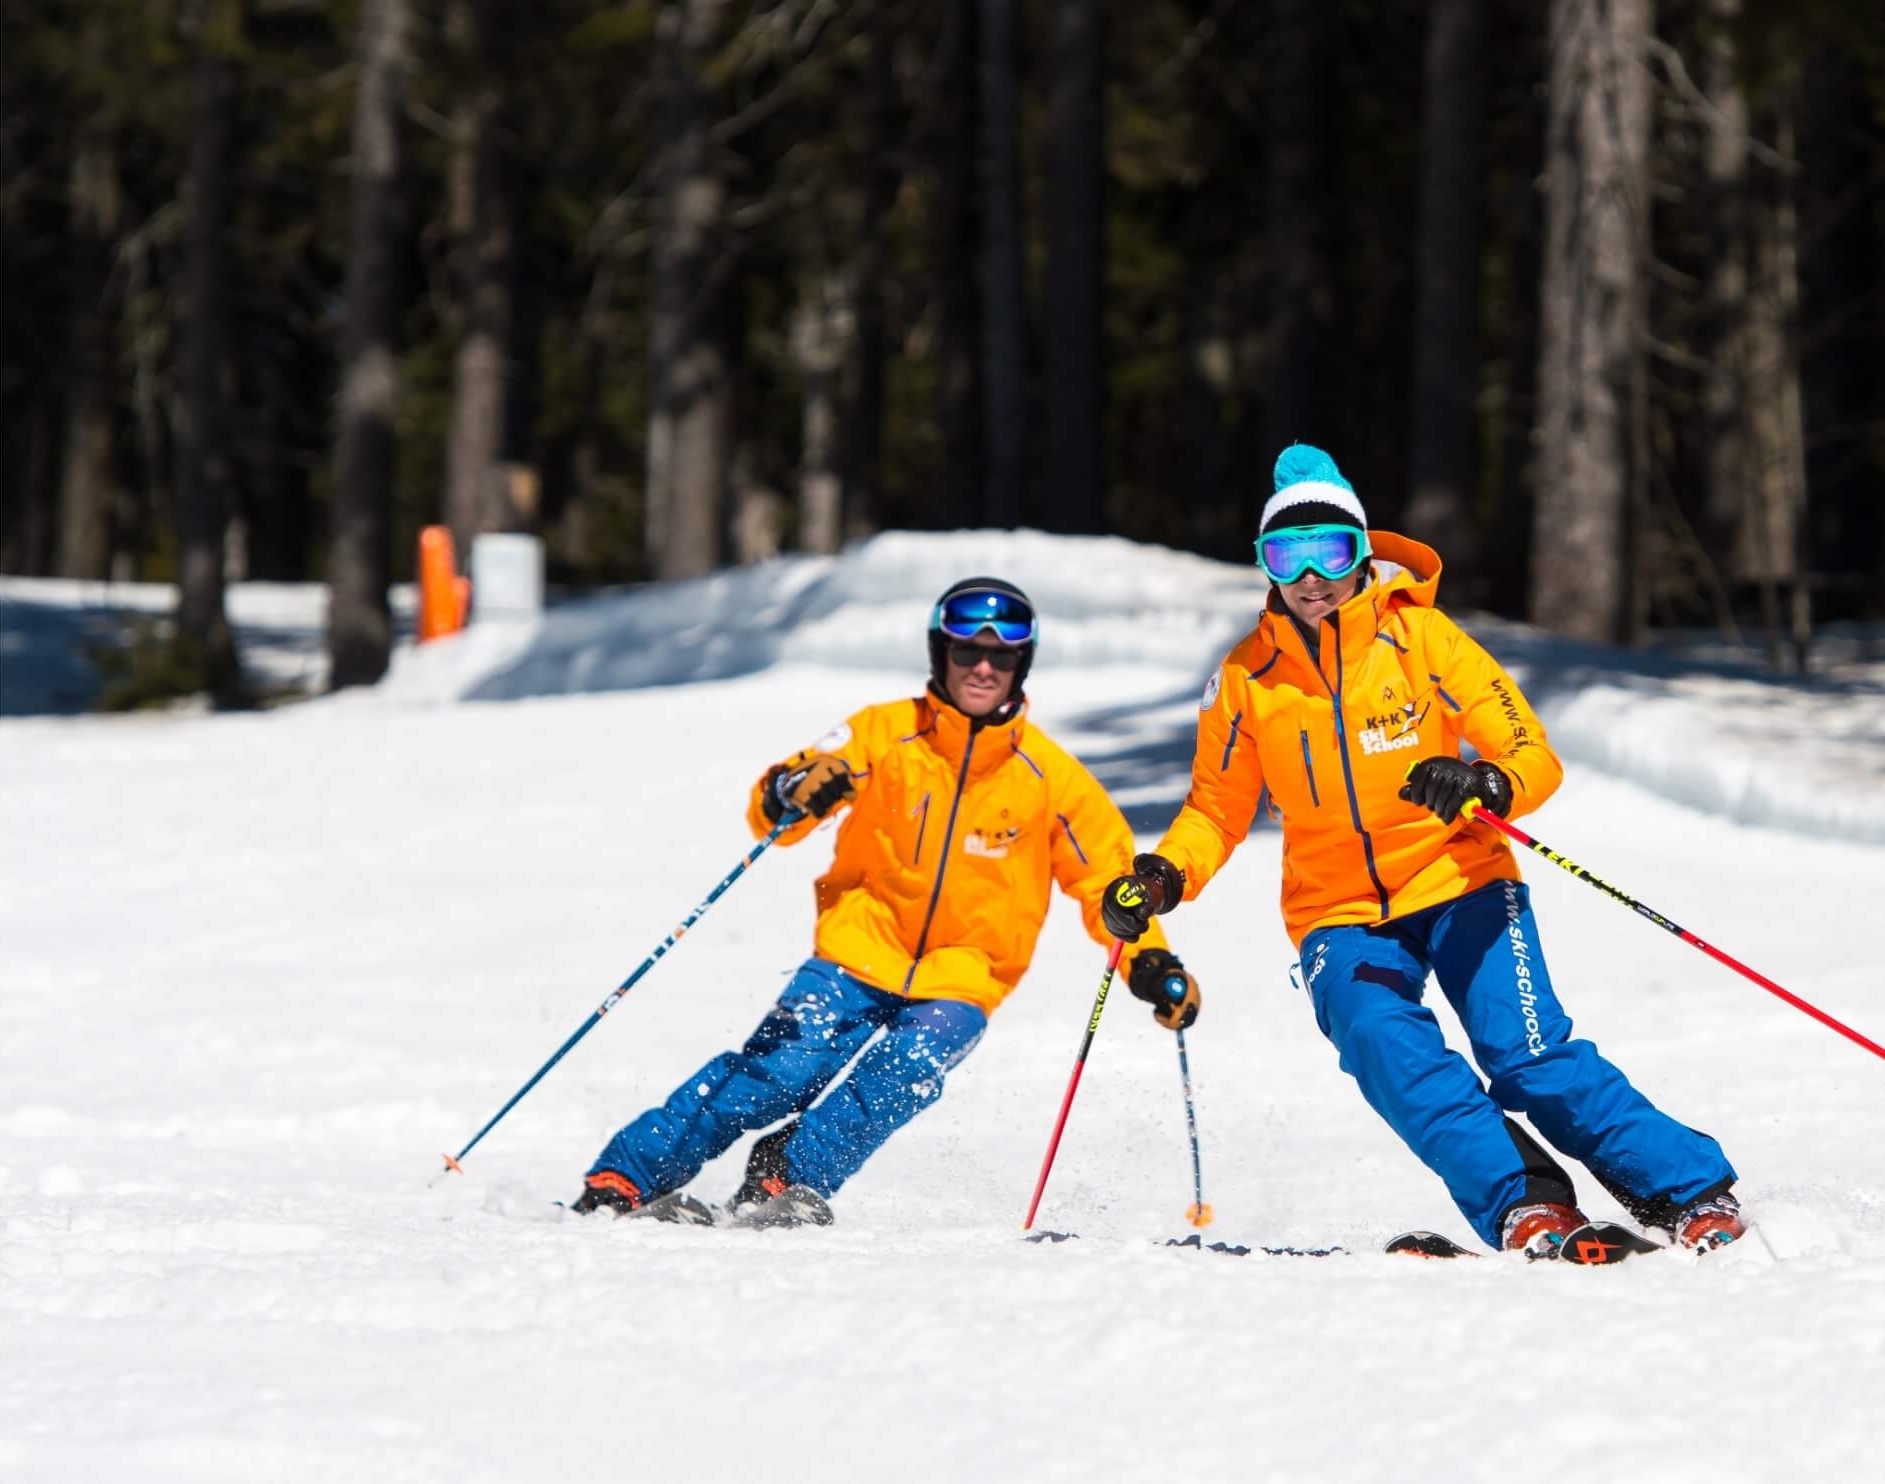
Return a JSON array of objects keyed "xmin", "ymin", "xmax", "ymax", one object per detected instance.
[{"xmin": 1159, "ymin": 532, "xmax": 1565, "ymax": 947}]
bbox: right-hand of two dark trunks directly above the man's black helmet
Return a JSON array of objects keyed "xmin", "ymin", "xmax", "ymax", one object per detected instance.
[{"xmin": 980, "ymin": 0, "xmax": 1027, "ymax": 528}]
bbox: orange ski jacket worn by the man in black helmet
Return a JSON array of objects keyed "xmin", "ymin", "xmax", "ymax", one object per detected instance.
[{"xmin": 746, "ymin": 694, "xmax": 1167, "ymax": 1011}]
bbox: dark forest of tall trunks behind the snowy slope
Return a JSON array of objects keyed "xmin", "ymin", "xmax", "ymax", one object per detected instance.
[{"xmin": 0, "ymin": 0, "xmax": 1885, "ymax": 703}]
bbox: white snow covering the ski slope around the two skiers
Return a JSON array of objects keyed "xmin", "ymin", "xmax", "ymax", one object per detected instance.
[{"xmin": 0, "ymin": 534, "xmax": 1885, "ymax": 1484}]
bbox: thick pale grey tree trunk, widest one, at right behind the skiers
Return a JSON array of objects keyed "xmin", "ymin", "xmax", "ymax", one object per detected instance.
[{"xmin": 1531, "ymin": 0, "xmax": 1649, "ymax": 643}]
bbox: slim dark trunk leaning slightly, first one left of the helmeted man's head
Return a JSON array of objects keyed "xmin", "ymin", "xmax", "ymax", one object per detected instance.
[{"xmin": 839, "ymin": 0, "xmax": 899, "ymax": 539}]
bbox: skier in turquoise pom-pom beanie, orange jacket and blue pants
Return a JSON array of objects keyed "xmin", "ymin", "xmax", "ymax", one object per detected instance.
[{"xmin": 1105, "ymin": 443, "xmax": 1742, "ymax": 1256}]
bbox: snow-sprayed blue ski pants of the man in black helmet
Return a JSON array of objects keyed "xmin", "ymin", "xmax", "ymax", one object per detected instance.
[{"xmin": 590, "ymin": 958, "xmax": 988, "ymax": 1197}]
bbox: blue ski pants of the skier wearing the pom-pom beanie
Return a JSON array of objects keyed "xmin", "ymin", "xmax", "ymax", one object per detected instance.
[{"xmin": 1303, "ymin": 881, "xmax": 1734, "ymax": 1246}]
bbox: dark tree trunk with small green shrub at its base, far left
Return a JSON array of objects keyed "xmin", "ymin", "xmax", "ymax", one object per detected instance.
[{"xmin": 172, "ymin": 4, "xmax": 241, "ymax": 703}]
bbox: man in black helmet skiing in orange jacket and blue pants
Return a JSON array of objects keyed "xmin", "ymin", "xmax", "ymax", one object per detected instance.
[{"xmin": 573, "ymin": 577, "xmax": 1199, "ymax": 1224}]
